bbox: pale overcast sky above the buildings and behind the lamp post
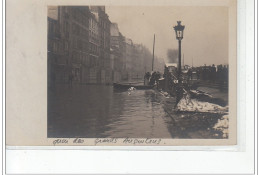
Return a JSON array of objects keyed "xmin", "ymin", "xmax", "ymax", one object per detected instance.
[{"xmin": 106, "ymin": 6, "xmax": 228, "ymax": 66}]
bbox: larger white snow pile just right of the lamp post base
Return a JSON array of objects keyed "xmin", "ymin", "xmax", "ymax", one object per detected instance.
[{"xmin": 177, "ymin": 94, "xmax": 228, "ymax": 113}]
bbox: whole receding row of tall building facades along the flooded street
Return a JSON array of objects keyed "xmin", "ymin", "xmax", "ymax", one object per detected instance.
[{"xmin": 48, "ymin": 6, "xmax": 164, "ymax": 84}]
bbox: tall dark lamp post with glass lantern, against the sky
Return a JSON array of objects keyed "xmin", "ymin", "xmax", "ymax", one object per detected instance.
[{"xmin": 173, "ymin": 21, "xmax": 185, "ymax": 105}]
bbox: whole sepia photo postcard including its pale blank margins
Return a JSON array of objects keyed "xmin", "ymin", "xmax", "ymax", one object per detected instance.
[{"xmin": 6, "ymin": 0, "xmax": 237, "ymax": 146}]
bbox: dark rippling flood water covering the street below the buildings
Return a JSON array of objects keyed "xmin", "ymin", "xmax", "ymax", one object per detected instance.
[{"xmin": 48, "ymin": 85, "xmax": 226, "ymax": 138}]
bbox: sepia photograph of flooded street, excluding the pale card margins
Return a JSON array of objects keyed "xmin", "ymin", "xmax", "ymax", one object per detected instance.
[{"xmin": 46, "ymin": 6, "xmax": 230, "ymax": 139}]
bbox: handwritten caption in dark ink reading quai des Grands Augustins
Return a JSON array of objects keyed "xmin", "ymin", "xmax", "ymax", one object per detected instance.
[{"xmin": 52, "ymin": 137, "xmax": 162, "ymax": 146}]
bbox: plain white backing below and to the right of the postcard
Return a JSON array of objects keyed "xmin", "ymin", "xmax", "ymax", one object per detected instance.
[{"xmin": 3, "ymin": 0, "xmax": 255, "ymax": 174}]
